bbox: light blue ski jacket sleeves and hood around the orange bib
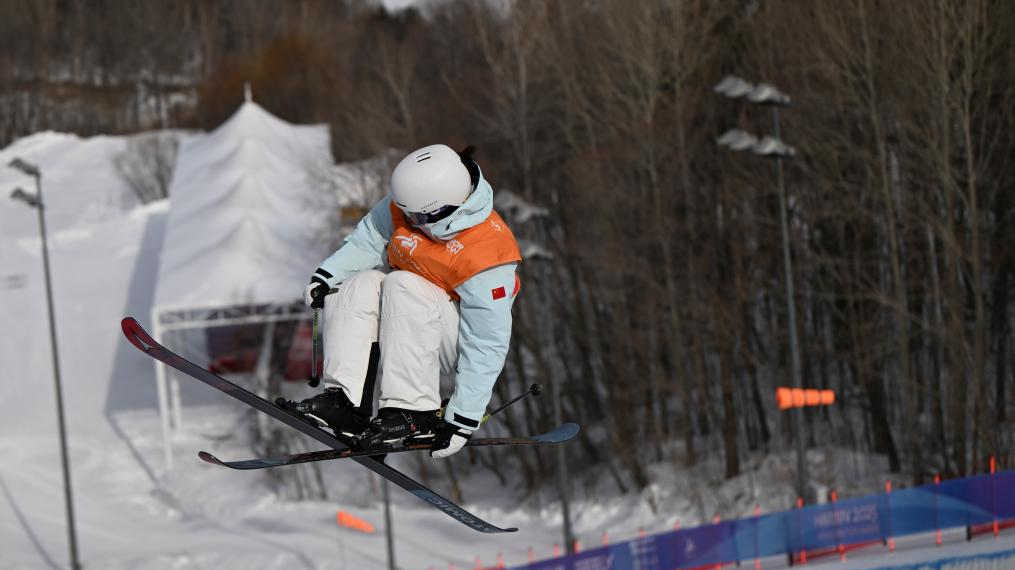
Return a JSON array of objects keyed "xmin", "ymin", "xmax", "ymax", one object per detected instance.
[{"xmin": 321, "ymin": 173, "xmax": 518, "ymax": 430}]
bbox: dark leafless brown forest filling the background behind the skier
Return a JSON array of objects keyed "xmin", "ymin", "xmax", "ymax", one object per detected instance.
[{"xmin": 0, "ymin": 0, "xmax": 1015, "ymax": 496}]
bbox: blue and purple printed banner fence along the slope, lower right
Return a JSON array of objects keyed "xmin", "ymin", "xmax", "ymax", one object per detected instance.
[{"xmin": 516, "ymin": 471, "xmax": 1015, "ymax": 570}]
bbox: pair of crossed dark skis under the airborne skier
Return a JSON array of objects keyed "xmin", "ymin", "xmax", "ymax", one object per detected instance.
[{"xmin": 121, "ymin": 316, "xmax": 579, "ymax": 532}]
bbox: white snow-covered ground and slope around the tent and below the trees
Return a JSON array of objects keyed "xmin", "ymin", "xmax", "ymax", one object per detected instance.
[{"xmin": 0, "ymin": 127, "xmax": 1010, "ymax": 570}]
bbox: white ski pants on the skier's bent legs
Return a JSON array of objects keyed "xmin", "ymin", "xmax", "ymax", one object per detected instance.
[{"xmin": 322, "ymin": 270, "xmax": 459, "ymax": 411}]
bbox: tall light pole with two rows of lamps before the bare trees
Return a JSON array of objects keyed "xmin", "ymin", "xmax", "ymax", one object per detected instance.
[{"xmin": 713, "ymin": 75, "xmax": 810, "ymax": 500}]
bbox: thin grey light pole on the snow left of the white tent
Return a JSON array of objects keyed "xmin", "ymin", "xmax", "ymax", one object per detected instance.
[{"xmin": 7, "ymin": 158, "xmax": 81, "ymax": 570}]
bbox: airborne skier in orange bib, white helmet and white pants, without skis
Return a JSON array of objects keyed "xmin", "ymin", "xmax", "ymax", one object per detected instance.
[{"xmin": 284, "ymin": 144, "xmax": 522, "ymax": 457}]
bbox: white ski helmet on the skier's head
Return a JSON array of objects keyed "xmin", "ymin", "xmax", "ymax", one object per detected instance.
[{"xmin": 391, "ymin": 144, "xmax": 472, "ymax": 226}]
